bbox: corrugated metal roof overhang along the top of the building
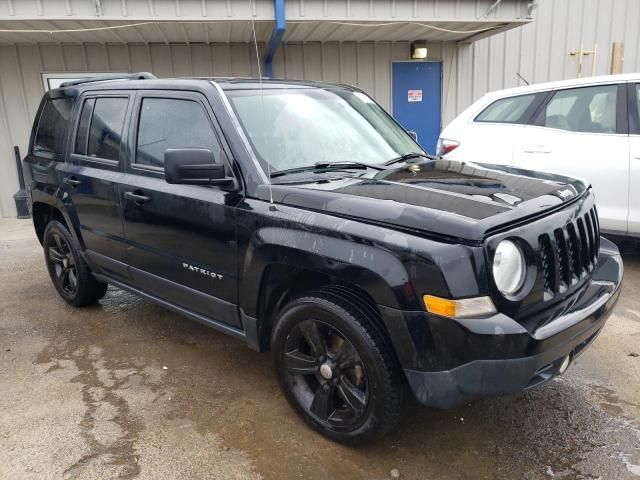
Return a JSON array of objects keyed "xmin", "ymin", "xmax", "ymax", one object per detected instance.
[{"xmin": 0, "ymin": 0, "xmax": 535, "ymax": 44}]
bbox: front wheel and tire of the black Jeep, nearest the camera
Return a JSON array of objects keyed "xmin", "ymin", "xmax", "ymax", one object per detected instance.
[{"xmin": 271, "ymin": 287, "xmax": 406, "ymax": 445}]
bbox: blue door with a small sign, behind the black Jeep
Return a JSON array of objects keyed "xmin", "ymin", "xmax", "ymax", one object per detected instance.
[{"xmin": 392, "ymin": 62, "xmax": 442, "ymax": 153}]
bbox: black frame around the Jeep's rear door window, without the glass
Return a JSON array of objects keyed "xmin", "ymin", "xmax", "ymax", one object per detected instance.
[{"xmin": 67, "ymin": 90, "xmax": 134, "ymax": 171}]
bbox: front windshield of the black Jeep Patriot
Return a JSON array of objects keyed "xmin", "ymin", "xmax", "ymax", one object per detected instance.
[{"xmin": 226, "ymin": 88, "xmax": 422, "ymax": 173}]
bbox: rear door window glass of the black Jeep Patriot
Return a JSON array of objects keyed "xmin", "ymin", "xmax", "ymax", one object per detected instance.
[{"xmin": 85, "ymin": 97, "xmax": 129, "ymax": 160}]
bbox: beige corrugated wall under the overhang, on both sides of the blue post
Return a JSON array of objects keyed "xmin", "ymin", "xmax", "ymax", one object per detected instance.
[{"xmin": 0, "ymin": 42, "xmax": 424, "ymax": 216}]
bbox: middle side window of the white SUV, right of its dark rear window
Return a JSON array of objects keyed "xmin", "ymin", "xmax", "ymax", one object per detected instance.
[{"xmin": 540, "ymin": 85, "xmax": 618, "ymax": 133}]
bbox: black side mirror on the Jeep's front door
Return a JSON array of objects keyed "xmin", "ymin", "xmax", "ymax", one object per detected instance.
[{"xmin": 164, "ymin": 148, "xmax": 233, "ymax": 186}]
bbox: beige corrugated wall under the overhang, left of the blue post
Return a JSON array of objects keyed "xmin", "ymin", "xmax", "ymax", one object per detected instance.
[{"xmin": 0, "ymin": 44, "xmax": 258, "ymax": 216}]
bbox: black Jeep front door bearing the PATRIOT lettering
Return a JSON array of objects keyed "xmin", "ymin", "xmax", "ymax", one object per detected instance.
[{"xmin": 120, "ymin": 91, "xmax": 240, "ymax": 327}]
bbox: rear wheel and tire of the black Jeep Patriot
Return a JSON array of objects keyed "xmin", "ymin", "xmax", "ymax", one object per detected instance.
[{"xmin": 42, "ymin": 220, "xmax": 107, "ymax": 307}]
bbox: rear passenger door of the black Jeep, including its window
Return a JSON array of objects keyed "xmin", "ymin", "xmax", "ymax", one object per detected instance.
[{"xmin": 60, "ymin": 91, "xmax": 131, "ymax": 278}]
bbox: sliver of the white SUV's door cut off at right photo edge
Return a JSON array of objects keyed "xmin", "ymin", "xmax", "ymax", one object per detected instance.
[{"xmin": 627, "ymin": 83, "xmax": 640, "ymax": 236}]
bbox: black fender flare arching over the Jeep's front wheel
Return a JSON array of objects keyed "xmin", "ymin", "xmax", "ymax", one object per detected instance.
[{"xmin": 240, "ymin": 226, "xmax": 430, "ymax": 368}]
